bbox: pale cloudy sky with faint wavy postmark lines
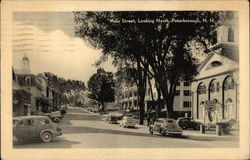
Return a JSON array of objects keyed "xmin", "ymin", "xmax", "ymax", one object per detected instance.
[{"xmin": 12, "ymin": 12, "xmax": 116, "ymax": 83}]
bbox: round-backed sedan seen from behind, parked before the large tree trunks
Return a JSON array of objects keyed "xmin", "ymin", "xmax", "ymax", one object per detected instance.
[{"xmin": 149, "ymin": 118, "xmax": 182, "ymax": 136}]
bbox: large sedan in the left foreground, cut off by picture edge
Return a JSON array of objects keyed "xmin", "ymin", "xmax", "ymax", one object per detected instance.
[{"xmin": 13, "ymin": 116, "xmax": 62, "ymax": 143}]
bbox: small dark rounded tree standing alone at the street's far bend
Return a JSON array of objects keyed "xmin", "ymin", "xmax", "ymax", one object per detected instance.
[{"xmin": 88, "ymin": 68, "xmax": 114, "ymax": 111}]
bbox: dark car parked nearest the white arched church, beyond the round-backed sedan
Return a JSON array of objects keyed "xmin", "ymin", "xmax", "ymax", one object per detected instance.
[{"xmin": 177, "ymin": 117, "xmax": 201, "ymax": 130}]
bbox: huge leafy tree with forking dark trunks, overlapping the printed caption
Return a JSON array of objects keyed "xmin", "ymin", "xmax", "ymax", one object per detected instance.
[{"xmin": 75, "ymin": 11, "xmax": 230, "ymax": 117}]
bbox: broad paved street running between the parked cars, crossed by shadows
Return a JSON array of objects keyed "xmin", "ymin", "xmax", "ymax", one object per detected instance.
[{"xmin": 15, "ymin": 108, "xmax": 238, "ymax": 148}]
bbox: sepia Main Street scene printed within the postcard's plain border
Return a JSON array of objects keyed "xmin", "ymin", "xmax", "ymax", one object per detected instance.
[{"xmin": 1, "ymin": 0, "xmax": 249, "ymax": 159}]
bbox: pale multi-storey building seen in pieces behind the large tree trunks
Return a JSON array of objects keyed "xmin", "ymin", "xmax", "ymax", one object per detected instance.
[{"xmin": 119, "ymin": 80, "xmax": 191, "ymax": 117}]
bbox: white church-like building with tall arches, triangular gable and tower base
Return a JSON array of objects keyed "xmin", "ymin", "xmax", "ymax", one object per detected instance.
[{"xmin": 192, "ymin": 15, "xmax": 239, "ymax": 123}]
